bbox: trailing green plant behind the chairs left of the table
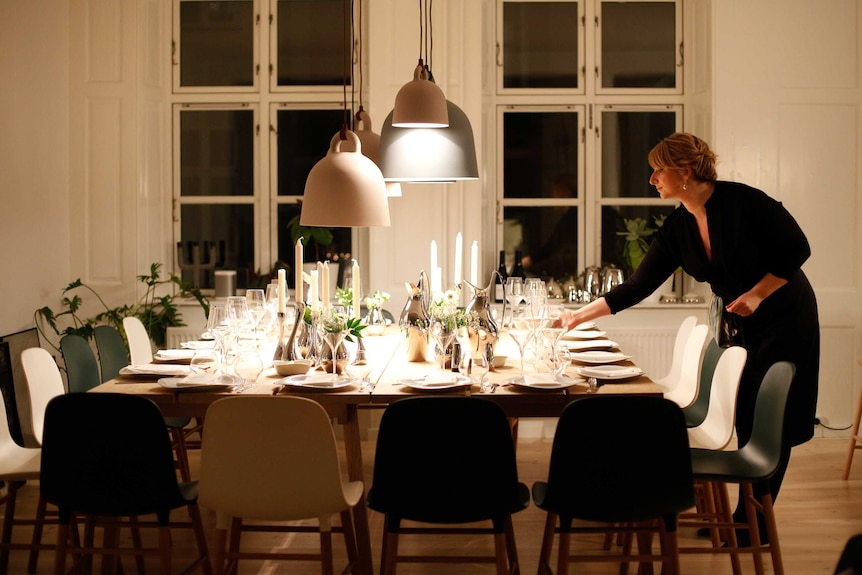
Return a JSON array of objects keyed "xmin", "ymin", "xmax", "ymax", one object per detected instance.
[{"xmin": 33, "ymin": 263, "xmax": 209, "ymax": 351}]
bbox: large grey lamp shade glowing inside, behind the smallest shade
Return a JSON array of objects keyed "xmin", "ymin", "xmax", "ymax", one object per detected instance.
[{"xmin": 379, "ymin": 100, "xmax": 479, "ymax": 183}]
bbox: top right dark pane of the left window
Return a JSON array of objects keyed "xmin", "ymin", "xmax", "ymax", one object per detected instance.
[{"xmin": 278, "ymin": 0, "xmax": 352, "ymax": 86}]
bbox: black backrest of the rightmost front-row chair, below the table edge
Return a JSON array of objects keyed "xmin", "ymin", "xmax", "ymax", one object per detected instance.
[{"xmin": 543, "ymin": 395, "xmax": 694, "ymax": 522}]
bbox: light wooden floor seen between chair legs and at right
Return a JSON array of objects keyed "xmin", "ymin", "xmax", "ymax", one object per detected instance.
[{"xmin": 9, "ymin": 438, "xmax": 862, "ymax": 575}]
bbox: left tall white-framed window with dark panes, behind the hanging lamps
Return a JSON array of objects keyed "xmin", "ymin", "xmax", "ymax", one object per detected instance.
[{"xmin": 173, "ymin": 0, "xmax": 353, "ymax": 289}]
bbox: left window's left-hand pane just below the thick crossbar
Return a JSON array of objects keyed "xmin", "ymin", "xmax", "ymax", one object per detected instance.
[{"xmin": 180, "ymin": 110, "xmax": 254, "ymax": 196}]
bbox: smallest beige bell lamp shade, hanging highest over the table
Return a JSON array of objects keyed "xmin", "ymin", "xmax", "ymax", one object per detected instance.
[{"xmin": 392, "ymin": 64, "xmax": 449, "ymax": 128}]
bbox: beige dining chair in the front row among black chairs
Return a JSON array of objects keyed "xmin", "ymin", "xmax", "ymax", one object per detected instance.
[{"xmin": 200, "ymin": 396, "xmax": 364, "ymax": 575}]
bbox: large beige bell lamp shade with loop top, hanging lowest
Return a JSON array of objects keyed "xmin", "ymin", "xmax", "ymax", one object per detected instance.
[{"xmin": 299, "ymin": 130, "xmax": 389, "ymax": 227}]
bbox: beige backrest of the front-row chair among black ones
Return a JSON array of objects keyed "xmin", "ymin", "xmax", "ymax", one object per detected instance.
[{"xmin": 198, "ymin": 396, "xmax": 348, "ymax": 521}]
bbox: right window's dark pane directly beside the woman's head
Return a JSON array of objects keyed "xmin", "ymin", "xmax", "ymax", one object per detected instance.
[{"xmin": 602, "ymin": 111, "xmax": 676, "ymax": 198}]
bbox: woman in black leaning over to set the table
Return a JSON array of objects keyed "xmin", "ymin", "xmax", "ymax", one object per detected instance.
[{"xmin": 568, "ymin": 133, "xmax": 820, "ymax": 541}]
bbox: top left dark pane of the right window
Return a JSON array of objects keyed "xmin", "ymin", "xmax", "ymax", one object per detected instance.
[{"xmin": 503, "ymin": 2, "xmax": 579, "ymax": 88}]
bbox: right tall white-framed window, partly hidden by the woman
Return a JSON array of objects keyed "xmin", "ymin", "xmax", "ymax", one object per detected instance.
[{"xmin": 494, "ymin": 0, "xmax": 683, "ymax": 285}]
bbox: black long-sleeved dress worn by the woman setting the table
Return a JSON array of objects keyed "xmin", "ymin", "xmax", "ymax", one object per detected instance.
[{"xmin": 606, "ymin": 182, "xmax": 820, "ymax": 446}]
